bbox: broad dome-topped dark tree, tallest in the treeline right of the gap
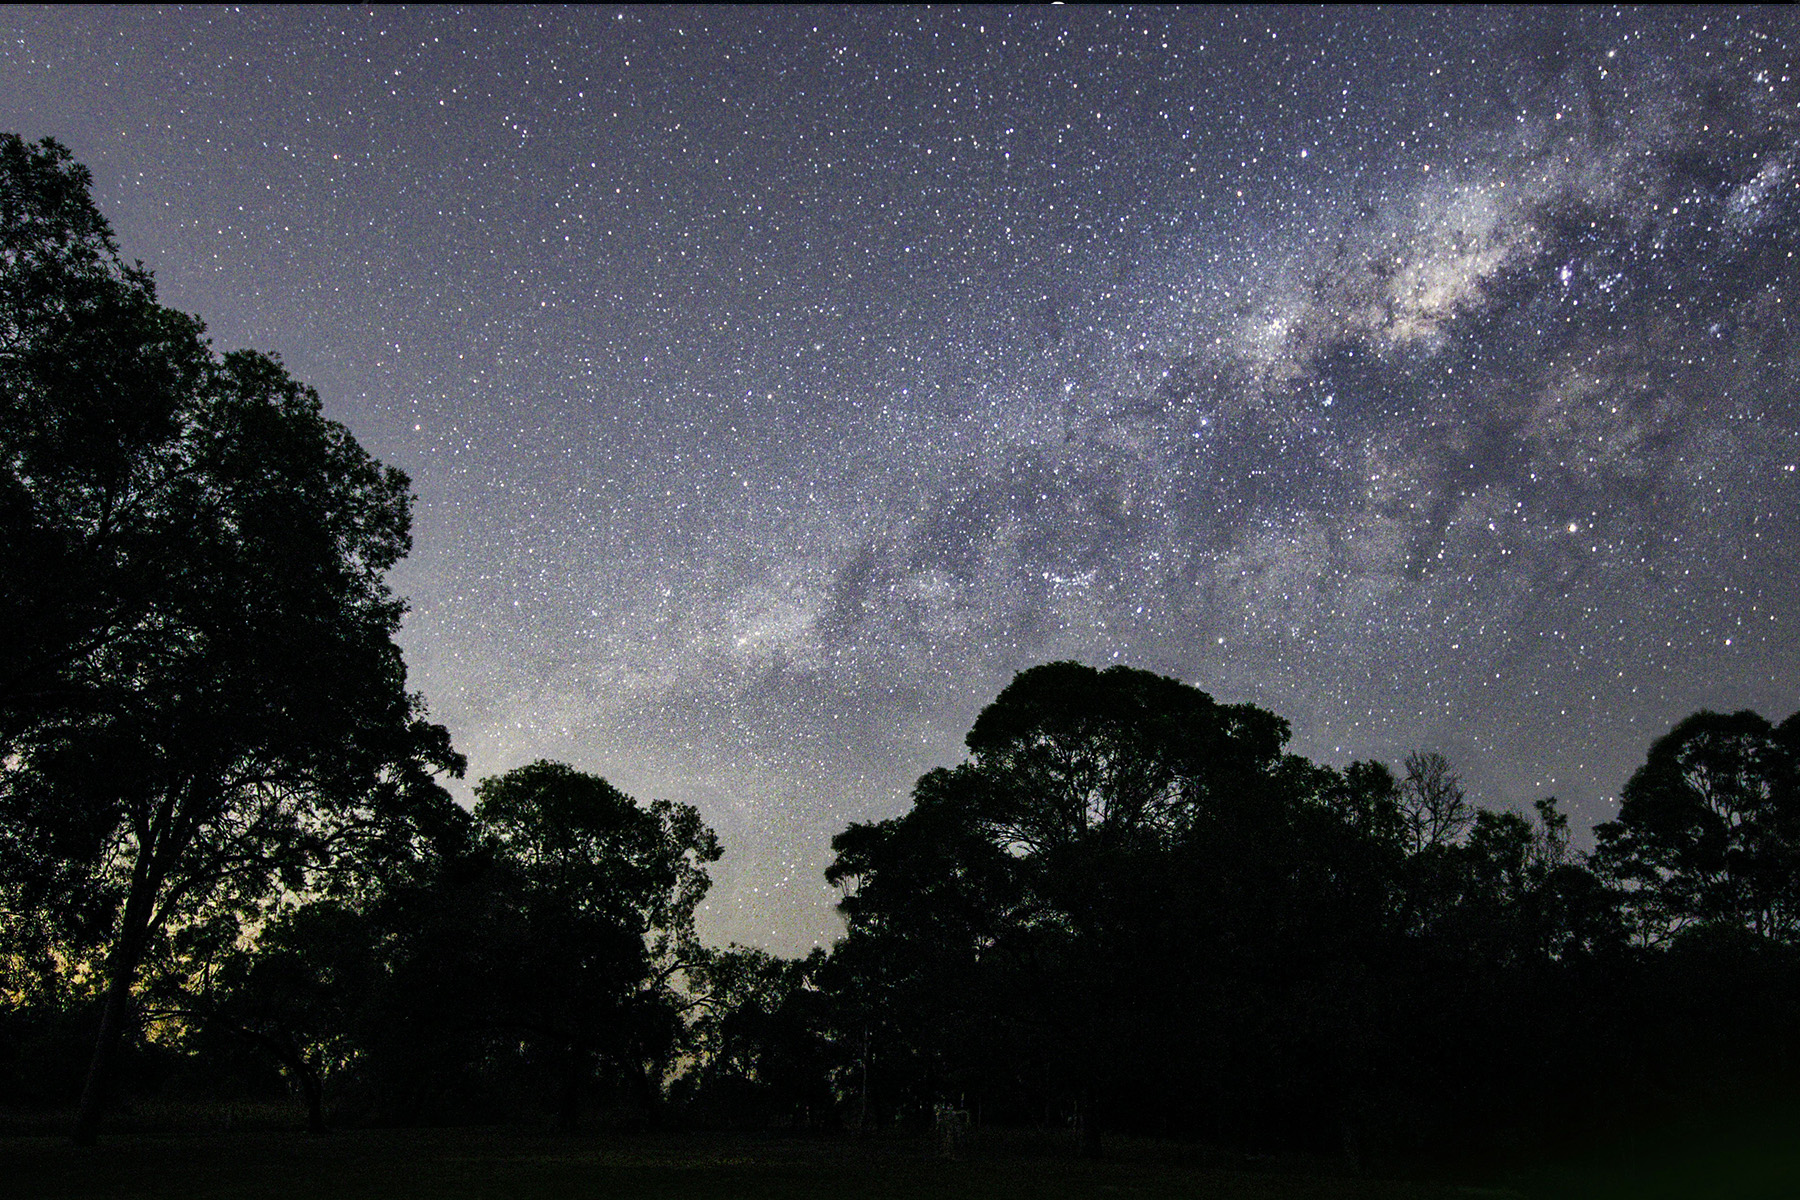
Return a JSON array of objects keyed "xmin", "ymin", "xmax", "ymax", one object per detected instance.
[{"xmin": 826, "ymin": 662, "xmax": 1336, "ymax": 1153}]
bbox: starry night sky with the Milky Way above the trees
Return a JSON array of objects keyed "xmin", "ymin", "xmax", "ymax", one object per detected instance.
[{"xmin": 0, "ymin": 7, "xmax": 1800, "ymax": 952}]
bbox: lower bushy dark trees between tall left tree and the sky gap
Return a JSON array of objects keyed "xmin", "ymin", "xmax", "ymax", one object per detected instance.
[{"xmin": 128, "ymin": 763, "xmax": 718, "ymax": 1128}]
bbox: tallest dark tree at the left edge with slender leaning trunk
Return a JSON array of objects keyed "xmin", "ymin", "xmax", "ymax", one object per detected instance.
[{"xmin": 0, "ymin": 135, "xmax": 461, "ymax": 1141}]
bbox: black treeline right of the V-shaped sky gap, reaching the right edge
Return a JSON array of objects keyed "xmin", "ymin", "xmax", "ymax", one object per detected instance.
[{"xmin": 814, "ymin": 662, "xmax": 1800, "ymax": 1157}]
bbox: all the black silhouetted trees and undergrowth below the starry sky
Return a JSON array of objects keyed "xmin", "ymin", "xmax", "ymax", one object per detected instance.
[{"xmin": 10, "ymin": 137, "xmax": 1800, "ymax": 1196}]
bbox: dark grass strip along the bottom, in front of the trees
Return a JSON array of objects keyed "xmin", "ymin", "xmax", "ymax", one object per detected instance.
[{"xmin": 0, "ymin": 1124, "xmax": 1800, "ymax": 1200}]
